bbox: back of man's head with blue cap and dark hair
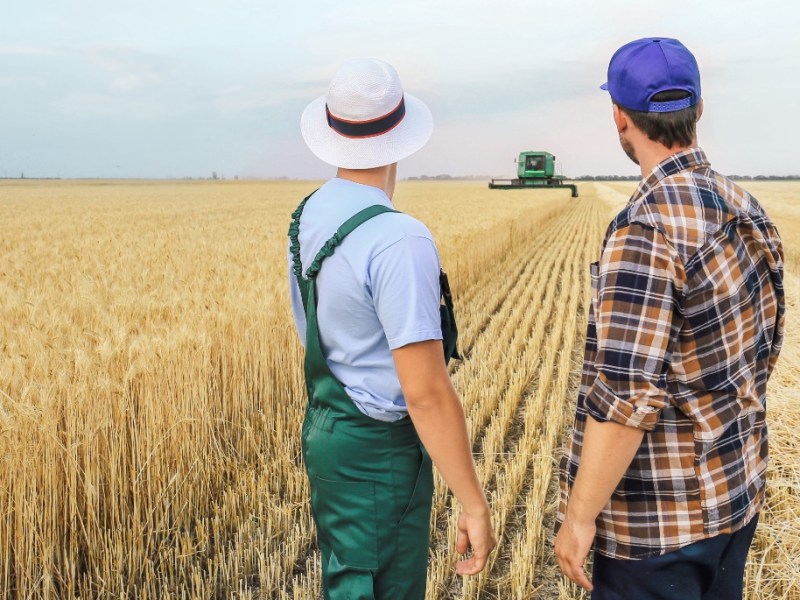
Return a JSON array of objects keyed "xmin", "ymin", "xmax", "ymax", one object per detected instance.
[{"xmin": 600, "ymin": 38, "xmax": 701, "ymax": 148}]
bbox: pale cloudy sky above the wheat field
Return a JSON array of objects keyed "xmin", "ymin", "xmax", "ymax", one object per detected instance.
[{"xmin": 0, "ymin": 0, "xmax": 800, "ymax": 179}]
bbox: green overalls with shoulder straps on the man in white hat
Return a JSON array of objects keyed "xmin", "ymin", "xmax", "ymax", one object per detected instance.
[{"xmin": 289, "ymin": 196, "xmax": 457, "ymax": 600}]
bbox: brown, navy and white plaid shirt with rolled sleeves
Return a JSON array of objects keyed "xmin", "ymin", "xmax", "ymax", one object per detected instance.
[{"xmin": 556, "ymin": 148, "xmax": 784, "ymax": 559}]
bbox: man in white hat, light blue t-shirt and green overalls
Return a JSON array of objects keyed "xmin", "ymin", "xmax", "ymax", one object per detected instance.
[{"xmin": 289, "ymin": 59, "xmax": 496, "ymax": 600}]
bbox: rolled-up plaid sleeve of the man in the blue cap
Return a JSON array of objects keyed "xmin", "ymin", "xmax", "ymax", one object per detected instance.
[{"xmin": 586, "ymin": 223, "xmax": 683, "ymax": 431}]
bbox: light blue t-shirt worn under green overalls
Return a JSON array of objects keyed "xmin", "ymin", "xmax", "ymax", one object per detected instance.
[{"xmin": 289, "ymin": 178, "xmax": 442, "ymax": 421}]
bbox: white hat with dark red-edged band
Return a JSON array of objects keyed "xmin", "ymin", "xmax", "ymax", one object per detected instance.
[{"xmin": 300, "ymin": 58, "xmax": 433, "ymax": 169}]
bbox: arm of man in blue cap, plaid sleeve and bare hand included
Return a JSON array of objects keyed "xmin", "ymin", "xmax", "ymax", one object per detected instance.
[{"xmin": 555, "ymin": 224, "xmax": 683, "ymax": 589}]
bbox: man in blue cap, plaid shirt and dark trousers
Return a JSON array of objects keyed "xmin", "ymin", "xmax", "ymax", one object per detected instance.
[{"xmin": 555, "ymin": 38, "xmax": 784, "ymax": 600}]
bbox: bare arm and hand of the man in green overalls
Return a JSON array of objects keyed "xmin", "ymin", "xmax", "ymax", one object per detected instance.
[{"xmin": 392, "ymin": 340, "xmax": 497, "ymax": 575}]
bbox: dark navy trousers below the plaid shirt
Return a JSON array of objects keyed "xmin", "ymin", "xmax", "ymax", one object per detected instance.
[{"xmin": 592, "ymin": 515, "xmax": 758, "ymax": 600}]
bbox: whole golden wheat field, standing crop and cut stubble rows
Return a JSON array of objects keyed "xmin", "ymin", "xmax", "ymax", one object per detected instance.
[{"xmin": 0, "ymin": 177, "xmax": 800, "ymax": 599}]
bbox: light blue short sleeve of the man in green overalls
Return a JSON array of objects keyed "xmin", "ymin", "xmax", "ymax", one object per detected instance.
[{"xmin": 368, "ymin": 236, "xmax": 442, "ymax": 350}]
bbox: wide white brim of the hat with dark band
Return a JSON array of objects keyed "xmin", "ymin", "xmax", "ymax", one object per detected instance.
[{"xmin": 300, "ymin": 94, "xmax": 433, "ymax": 169}]
